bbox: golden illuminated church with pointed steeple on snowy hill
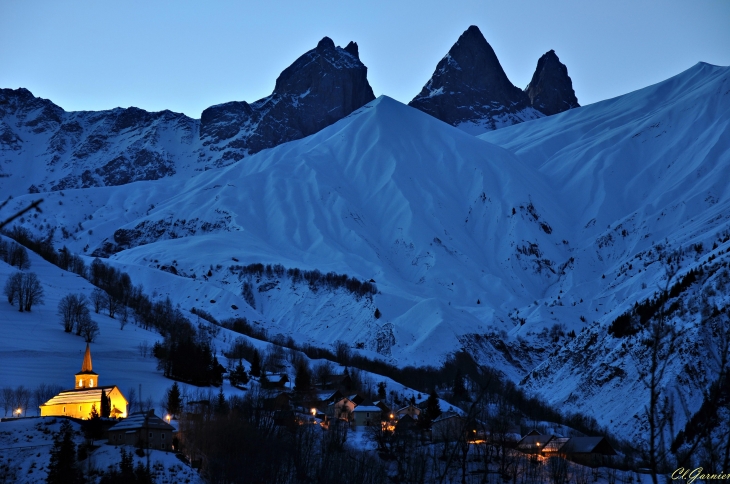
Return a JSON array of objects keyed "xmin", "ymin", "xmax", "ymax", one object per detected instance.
[{"xmin": 40, "ymin": 343, "xmax": 127, "ymax": 419}]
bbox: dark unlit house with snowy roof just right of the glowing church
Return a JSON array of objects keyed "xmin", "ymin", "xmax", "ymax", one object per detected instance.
[{"xmin": 108, "ymin": 410, "xmax": 175, "ymax": 450}]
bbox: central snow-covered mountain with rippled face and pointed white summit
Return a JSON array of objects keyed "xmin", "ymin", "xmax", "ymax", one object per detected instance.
[{"xmin": 0, "ymin": 97, "xmax": 569, "ymax": 363}]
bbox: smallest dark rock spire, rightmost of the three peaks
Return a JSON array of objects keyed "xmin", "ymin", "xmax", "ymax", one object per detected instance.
[{"xmin": 525, "ymin": 50, "xmax": 580, "ymax": 116}]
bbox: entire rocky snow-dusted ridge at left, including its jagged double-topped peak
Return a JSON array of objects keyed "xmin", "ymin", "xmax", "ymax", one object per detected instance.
[{"xmin": 0, "ymin": 37, "xmax": 375, "ymax": 195}]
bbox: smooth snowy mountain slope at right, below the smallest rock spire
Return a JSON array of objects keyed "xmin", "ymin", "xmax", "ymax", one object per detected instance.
[{"xmin": 481, "ymin": 63, "xmax": 730, "ymax": 435}]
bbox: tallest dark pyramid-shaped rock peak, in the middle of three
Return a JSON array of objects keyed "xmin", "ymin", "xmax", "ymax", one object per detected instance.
[{"xmin": 408, "ymin": 25, "xmax": 541, "ymax": 133}]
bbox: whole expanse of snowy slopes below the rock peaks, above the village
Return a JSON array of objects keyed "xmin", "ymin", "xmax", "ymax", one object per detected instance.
[{"xmin": 0, "ymin": 64, "xmax": 730, "ymax": 435}]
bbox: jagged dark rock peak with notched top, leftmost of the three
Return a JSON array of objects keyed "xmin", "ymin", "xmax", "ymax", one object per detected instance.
[{"xmin": 200, "ymin": 37, "xmax": 375, "ymax": 160}]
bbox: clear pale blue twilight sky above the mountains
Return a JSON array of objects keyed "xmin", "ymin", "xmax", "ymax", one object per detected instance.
[{"xmin": 0, "ymin": 0, "xmax": 730, "ymax": 118}]
